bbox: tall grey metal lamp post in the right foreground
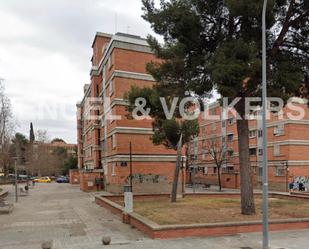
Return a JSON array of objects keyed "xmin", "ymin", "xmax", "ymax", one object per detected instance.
[{"xmin": 262, "ymin": 0, "xmax": 269, "ymax": 249}]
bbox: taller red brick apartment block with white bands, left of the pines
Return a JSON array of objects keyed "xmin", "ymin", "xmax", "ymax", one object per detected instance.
[{"xmin": 77, "ymin": 33, "xmax": 176, "ymax": 193}]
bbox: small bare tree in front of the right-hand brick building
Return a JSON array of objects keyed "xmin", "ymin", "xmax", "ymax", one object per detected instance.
[{"xmin": 205, "ymin": 137, "xmax": 232, "ymax": 192}]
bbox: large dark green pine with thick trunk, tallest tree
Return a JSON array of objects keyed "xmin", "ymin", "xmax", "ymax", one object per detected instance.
[{"xmin": 142, "ymin": 0, "xmax": 309, "ymax": 215}]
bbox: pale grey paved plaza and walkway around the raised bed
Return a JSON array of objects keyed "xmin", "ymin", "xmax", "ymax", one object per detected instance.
[{"xmin": 0, "ymin": 183, "xmax": 309, "ymax": 249}]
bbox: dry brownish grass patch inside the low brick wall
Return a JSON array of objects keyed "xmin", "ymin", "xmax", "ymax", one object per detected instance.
[{"xmin": 114, "ymin": 197, "xmax": 309, "ymax": 225}]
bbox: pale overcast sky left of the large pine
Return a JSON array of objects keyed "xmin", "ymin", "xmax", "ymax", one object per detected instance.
[{"xmin": 0, "ymin": 0, "xmax": 159, "ymax": 143}]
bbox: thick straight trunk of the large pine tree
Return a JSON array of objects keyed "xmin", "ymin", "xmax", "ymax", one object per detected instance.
[{"xmin": 236, "ymin": 98, "xmax": 255, "ymax": 215}]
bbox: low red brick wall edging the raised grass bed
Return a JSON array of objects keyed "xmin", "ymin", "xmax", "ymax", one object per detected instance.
[{"xmin": 95, "ymin": 193, "xmax": 309, "ymax": 239}]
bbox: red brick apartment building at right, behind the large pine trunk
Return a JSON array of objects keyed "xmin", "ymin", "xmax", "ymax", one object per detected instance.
[{"xmin": 187, "ymin": 100, "xmax": 309, "ymax": 191}]
